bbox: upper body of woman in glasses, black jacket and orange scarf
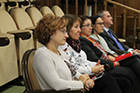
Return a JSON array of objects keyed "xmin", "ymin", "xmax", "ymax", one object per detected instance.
[{"xmin": 80, "ymin": 16, "xmax": 119, "ymax": 68}]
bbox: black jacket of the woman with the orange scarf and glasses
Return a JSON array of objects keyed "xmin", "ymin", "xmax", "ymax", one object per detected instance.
[{"xmin": 79, "ymin": 37, "xmax": 113, "ymax": 68}]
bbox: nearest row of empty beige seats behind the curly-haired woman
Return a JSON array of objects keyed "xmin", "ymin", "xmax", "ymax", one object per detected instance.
[{"xmin": 0, "ymin": 1, "xmax": 64, "ymax": 86}]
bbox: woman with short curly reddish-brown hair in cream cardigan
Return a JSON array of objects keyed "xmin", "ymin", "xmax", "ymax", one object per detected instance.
[{"xmin": 33, "ymin": 14, "xmax": 94, "ymax": 91}]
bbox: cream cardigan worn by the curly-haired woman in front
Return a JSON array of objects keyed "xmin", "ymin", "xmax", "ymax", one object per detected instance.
[{"xmin": 33, "ymin": 46, "xmax": 84, "ymax": 90}]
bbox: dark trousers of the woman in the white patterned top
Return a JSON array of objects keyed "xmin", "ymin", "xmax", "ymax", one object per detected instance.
[{"xmin": 87, "ymin": 75, "xmax": 131, "ymax": 93}]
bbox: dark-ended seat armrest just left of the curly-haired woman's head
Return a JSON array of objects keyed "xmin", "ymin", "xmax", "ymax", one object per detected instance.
[{"xmin": 7, "ymin": 30, "xmax": 31, "ymax": 40}]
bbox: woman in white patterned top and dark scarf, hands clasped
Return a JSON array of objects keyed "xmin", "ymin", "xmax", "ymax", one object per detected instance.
[{"xmin": 60, "ymin": 14, "xmax": 131, "ymax": 93}]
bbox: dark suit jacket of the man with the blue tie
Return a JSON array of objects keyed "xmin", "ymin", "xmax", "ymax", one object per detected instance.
[{"xmin": 99, "ymin": 29, "xmax": 129, "ymax": 52}]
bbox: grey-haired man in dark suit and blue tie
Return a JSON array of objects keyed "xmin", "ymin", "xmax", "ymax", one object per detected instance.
[{"xmin": 98, "ymin": 10, "xmax": 140, "ymax": 54}]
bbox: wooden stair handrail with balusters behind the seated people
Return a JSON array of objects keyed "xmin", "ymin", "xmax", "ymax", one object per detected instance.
[{"xmin": 63, "ymin": 0, "xmax": 140, "ymax": 45}]
